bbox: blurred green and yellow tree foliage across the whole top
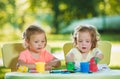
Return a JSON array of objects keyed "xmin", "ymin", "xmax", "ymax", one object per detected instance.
[{"xmin": 0, "ymin": 0, "xmax": 120, "ymax": 33}]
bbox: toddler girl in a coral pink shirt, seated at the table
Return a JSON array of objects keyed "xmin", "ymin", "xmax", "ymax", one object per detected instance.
[{"xmin": 18, "ymin": 25, "xmax": 61, "ymax": 70}]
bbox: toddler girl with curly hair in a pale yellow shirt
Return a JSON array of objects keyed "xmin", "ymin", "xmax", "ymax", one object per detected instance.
[{"xmin": 66, "ymin": 25, "xmax": 103, "ymax": 68}]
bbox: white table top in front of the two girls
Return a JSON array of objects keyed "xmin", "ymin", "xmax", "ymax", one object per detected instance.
[{"xmin": 5, "ymin": 70, "xmax": 120, "ymax": 79}]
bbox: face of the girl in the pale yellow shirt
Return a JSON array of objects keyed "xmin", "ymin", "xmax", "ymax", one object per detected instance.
[{"xmin": 77, "ymin": 32, "xmax": 92, "ymax": 53}]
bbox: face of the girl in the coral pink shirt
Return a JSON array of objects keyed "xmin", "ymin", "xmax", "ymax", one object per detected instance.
[{"xmin": 28, "ymin": 33, "xmax": 46, "ymax": 53}]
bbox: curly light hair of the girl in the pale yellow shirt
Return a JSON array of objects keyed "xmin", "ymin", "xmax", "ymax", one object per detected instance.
[{"xmin": 73, "ymin": 24, "xmax": 100, "ymax": 50}]
